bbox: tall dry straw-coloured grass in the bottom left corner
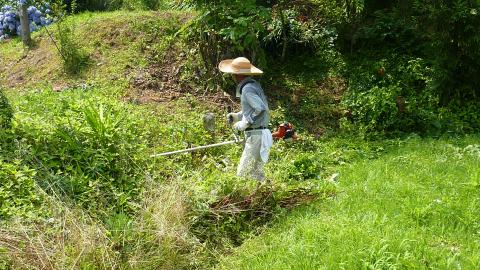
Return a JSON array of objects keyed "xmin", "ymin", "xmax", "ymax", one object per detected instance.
[{"xmin": 0, "ymin": 177, "xmax": 204, "ymax": 269}]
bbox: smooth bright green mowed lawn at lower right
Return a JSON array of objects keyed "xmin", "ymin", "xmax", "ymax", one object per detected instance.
[{"xmin": 218, "ymin": 136, "xmax": 480, "ymax": 269}]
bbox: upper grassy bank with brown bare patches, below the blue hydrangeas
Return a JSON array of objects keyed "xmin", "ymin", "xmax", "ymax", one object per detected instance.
[{"xmin": 0, "ymin": 11, "xmax": 232, "ymax": 103}]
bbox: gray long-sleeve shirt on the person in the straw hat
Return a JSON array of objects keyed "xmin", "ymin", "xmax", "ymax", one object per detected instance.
[{"xmin": 237, "ymin": 77, "xmax": 270, "ymax": 128}]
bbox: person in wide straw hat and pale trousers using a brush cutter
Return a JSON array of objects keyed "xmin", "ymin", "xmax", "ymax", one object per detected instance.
[{"xmin": 218, "ymin": 57, "xmax": 273, "ymax": 182}]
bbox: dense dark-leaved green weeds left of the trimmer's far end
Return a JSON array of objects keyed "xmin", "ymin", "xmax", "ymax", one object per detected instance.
[{"xmin": 11, "ymin": 88, "xmax": 143, "ymax": 214}]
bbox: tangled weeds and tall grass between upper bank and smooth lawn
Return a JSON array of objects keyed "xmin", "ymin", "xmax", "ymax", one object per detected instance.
[{"xmin": 0, "ymin": 83, "xmax": 358, "ymax": 269}]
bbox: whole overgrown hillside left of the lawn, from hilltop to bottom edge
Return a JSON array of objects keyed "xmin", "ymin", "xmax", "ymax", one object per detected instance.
[{"xmin": 0, "ymin": 8, "xmax": 341, "ymax": 269}]
